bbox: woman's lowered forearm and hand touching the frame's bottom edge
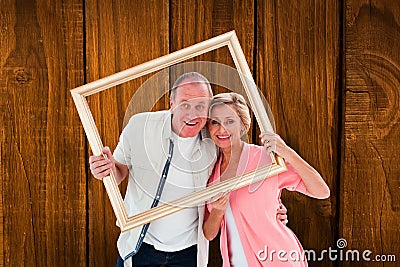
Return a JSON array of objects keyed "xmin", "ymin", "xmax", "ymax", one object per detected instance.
[{"xmin": 203, "ymin": 193, "xmax": 230, "ymax": 241}]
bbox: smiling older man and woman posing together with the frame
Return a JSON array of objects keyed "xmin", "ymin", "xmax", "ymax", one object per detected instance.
[{"xmin": 89, "ymin": 72, "xmax": 329, "ymax": 267}]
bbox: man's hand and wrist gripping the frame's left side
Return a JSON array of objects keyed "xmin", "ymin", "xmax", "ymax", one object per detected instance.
[{"xmin": 89, "ymin": 147, "xmax": 129, "ymax": 184}]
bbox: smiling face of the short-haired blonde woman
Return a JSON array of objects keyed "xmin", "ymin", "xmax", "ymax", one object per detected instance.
[{"xmin": 208, "ymin": 104, "xmax": 244, "ymax": 151}]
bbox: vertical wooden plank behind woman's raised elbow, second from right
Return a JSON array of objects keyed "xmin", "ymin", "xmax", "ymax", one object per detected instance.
[{"xmin": 256, "ymin": 0, "xmax": 341, "ymax": 266}]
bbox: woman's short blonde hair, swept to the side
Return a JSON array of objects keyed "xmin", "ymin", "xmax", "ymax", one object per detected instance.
[{"xmin": 209, "ymin": 92, "xmax": 251, "ymax": 135}]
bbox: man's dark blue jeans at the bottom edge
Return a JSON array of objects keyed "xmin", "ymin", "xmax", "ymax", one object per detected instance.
[{"xmin": 117, "ymin": 243, "xmax": 197, "ymax": 267}]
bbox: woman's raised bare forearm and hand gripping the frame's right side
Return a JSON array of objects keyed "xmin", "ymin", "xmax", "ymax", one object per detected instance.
[{"xmin": 260, "ymin": 133, "xmax": 330, "ymax": 199}]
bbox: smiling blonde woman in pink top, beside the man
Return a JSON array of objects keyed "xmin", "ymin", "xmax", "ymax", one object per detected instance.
[{"xmin": 203, "ymin": 93, "xmax": 329, "ymax": 267}]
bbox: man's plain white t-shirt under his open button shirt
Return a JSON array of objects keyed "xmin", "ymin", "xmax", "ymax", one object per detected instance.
[{"xmin": 144, "ymin": 133, "xmax": 199, "ymax": 251}]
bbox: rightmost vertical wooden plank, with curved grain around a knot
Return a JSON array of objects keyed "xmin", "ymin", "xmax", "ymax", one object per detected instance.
[{"xmin": 340, "ymin": 0, "xmax": 400, "ymax": 266}]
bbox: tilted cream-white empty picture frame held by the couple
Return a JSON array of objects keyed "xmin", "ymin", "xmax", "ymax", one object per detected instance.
[{"xmin": 71, "ymin": 31, "xmax": 287, "ymax": 231}]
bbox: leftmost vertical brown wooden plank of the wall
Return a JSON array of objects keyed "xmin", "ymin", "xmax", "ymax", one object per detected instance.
[{"xmin": 0, "ymin": 0, "xmax": 86, "ymax": 266}]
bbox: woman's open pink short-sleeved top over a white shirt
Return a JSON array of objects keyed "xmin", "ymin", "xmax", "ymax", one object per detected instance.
[{"xmin": 207, "ymin": 143, "xmax": 307, "ymax": 267}]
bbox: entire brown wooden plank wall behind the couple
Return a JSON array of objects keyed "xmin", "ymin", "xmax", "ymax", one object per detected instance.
[{"xmin": 0, "ymin": 0, "xmax": 400, "ymax": 266}]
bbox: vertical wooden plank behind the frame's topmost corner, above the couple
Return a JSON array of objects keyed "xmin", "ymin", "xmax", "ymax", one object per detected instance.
[{"xmin": 170, "ymin": 0, "xmax": 255, "ymax": 266}]
